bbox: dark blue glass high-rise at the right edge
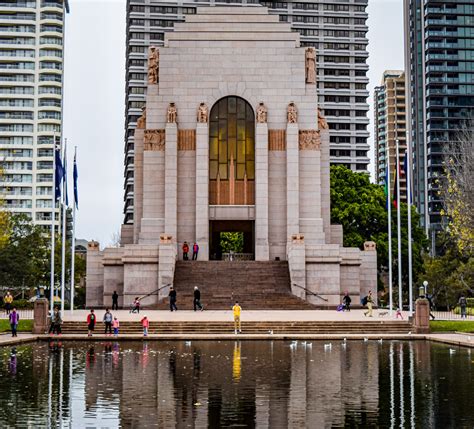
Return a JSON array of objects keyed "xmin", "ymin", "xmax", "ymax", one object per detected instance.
[{"xmin": 405, "ymin": 0, "xmax": 474, "ymax": 235}]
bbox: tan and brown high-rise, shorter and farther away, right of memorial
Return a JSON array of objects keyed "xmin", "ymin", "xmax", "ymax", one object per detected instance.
[{"xmin": 374, "ymin": 70, "xmax": 407, "ymax": 202}]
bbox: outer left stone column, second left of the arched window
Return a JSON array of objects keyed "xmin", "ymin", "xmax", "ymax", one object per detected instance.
[{"xmin": 165, "ymin": 123, "xmax": 178, "ymax": 243}]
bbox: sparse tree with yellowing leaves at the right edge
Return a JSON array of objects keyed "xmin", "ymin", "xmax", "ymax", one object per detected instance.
[{"xmin": 438, "ymin": 119, "xmax": 474, "ymax": 256}]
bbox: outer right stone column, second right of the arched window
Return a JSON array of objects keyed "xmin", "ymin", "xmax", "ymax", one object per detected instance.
[{"xmin": 286, "ymin": 123, "xmax": 300, "ymax": 242}]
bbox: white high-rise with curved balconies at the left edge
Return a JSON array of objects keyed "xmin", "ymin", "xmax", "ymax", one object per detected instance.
[{"xmin": 0, "ymin": 0, "xmax": 69, "ymax": 228}]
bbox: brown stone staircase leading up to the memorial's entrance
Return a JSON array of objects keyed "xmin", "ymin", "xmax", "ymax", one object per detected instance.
[{"xmin": 154, "ymin": 261, "xmax": 316, "ymax": 310}]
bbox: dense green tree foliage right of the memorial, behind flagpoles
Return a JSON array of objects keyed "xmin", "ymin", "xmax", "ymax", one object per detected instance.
[{"xmin": 331, "ymin": 166, "xmax": 428, "ymax": 294}]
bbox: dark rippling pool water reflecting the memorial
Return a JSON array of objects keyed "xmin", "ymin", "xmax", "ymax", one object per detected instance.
[{"xmin": 0, "ymin": 341, "xmax": 474, "ymax": 428}]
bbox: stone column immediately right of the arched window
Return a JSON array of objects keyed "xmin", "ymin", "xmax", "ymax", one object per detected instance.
[{"xmin": 255, "ymin": 123, "xmax": 270, "ymax": 261}]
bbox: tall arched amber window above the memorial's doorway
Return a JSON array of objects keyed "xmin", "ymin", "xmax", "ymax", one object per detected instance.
[{"xmin": 209, "ymin": 97, "xmax": 255, "ymax": 205}]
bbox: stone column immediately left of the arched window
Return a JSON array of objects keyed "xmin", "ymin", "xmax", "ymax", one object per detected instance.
[{"xmin": 196, "ymin": 123, "xmax": 209, "ymax": 261}]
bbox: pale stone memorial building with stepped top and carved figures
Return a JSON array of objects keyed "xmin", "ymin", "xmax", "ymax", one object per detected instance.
[{"xmin": 87, "ymin": 7, "xmax": 377, "ymax": 307}]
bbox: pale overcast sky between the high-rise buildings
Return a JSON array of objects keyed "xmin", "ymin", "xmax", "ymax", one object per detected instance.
[{"xmin": 64, "ymin": 0, "xmax": 403, "ymax": 246}]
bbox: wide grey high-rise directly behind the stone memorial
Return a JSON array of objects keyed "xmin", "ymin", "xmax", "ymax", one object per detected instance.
[{"xmin": 124, "ymin": 0, "xmax": 369, "ymax": 223}]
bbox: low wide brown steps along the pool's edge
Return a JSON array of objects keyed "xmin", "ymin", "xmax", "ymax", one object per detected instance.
[{"xmin": 62, "ymin": 316, "xmax": 412, "ymax": 336}]
